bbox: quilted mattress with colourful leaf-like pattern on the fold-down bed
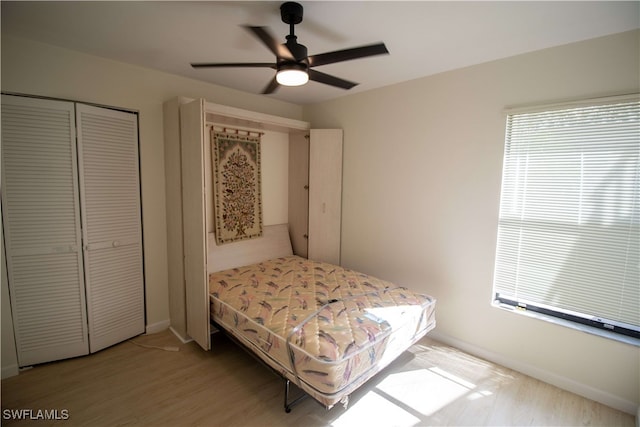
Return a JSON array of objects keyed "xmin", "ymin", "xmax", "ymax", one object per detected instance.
[{"xmin": 209, "ymin": 256, "xmax": 435, "ymax": 408}]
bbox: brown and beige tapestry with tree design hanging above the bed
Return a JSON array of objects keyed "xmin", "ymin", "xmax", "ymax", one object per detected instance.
[{"xmin": 211, "ymin": 129, "xmax": 262, "ymax": 245}]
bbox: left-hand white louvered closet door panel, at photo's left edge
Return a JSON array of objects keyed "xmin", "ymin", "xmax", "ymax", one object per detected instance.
[{"xmin": 2, "ymin": 95, "xmax": 89, "ymax": 366}]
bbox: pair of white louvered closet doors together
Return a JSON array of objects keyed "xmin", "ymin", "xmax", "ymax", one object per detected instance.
[{"xmin": 2, "ymin": 95, "xmax": 144, "ymax": 366}]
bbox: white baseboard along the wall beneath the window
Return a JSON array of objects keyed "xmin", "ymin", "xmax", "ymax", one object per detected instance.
[{"xmin": 429, "ymin": 331, "xmax": 640, "ymax": 416}]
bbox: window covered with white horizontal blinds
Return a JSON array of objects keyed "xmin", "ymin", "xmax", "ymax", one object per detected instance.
[{"xmin": 494, "ymin": 96, "xmax": 640, "ymax": 338}]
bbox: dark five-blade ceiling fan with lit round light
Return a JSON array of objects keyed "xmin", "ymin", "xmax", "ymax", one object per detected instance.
[{"xmin": 191, "ymin": 2, "xmax": 389, "ymax": 94}]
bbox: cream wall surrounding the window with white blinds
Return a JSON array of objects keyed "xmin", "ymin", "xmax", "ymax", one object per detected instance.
[{"xmin": 304, "ymin": 31, "xmax": 640, "ymax": 414}]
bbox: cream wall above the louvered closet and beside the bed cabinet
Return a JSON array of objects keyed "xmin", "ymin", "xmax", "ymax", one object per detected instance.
[{"xmin": 1, "ymin": 35, "xmax": 302, "ymax": 374}]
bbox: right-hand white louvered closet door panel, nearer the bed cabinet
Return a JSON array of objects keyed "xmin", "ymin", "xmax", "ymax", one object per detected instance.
[{"xmin": 76, "ymin": 104, "xmax": 145, "ymax": 352}]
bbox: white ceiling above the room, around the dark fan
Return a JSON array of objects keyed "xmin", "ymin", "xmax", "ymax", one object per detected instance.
[{"xmin": 1, "ymin": 0, "xmax": 640, "ymax": 104}]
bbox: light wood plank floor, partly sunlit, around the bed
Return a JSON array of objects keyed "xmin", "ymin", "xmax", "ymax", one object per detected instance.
[{"xmin": 2, "ymin": 331, "xmax": 635, "ymax": 427}]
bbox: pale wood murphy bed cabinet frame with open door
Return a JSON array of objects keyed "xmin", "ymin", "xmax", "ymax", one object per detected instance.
[{"xmin": 164, "ymin": 98, "xmax": 342, "ymax": 350}]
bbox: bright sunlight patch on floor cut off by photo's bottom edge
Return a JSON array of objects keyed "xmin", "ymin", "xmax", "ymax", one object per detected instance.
[{"xmin": 331, "ymin": 391, "xmax": 420, "ymax": 427}]
